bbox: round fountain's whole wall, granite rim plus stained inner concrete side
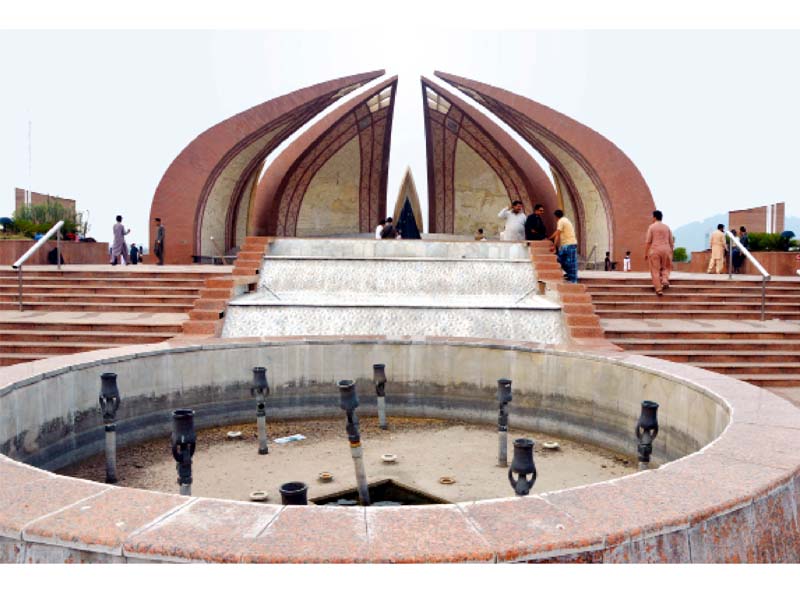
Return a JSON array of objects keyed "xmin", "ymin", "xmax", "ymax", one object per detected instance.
[{"xmin": 0, "ymin": 337, "xmax": 800, "ymax": 562}]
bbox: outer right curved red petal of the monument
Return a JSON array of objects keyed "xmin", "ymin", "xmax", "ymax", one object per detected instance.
[{"xmin": 435, "ymin": 71, "xmax": 655, "ymax": 270}]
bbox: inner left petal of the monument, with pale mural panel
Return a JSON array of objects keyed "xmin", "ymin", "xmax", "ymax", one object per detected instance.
[{"xmin": 253, "ymin": 77, "xmax": 397, "ymax": 239}]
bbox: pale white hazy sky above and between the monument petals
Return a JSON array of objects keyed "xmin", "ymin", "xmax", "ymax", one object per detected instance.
[{"xmin": 0, "ymin": 30, "xmax": 800, "ymax": 242}]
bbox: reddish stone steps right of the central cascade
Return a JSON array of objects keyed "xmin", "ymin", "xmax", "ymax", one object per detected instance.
[{"xmin": 581, "ymin": 274, "xmax": 800, "ymax": 387}]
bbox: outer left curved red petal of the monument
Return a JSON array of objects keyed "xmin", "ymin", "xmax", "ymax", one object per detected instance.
[{"xmin": 150, "ymin": 71, "xmax": 384, "ymax": 264}]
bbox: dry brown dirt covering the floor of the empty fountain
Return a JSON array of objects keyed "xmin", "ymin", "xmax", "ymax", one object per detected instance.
[{"xmin": 59, "ymin": 417, "xmax": 636, "ymax": 504}]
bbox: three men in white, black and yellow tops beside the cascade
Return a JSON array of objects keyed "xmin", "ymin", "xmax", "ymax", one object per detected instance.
[{"xmin": 496, "ymin": 200, "xmax": 578, "ymax": 283}]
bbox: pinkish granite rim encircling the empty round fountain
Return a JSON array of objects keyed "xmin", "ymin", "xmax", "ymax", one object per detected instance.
[{"xmin": 0, "ymin": 336, "xmax": 800, "ymax": 563}]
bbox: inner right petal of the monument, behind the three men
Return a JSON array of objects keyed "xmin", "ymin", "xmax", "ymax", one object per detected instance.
[{"xmin": 422, "ymin": 77, "xmax": 558, "ymax": 237}]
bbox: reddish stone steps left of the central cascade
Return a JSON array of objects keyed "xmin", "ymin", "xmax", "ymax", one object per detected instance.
[{"xmin": 0, "ymin": 265, "xmax": 231, "ymax": 366}]
